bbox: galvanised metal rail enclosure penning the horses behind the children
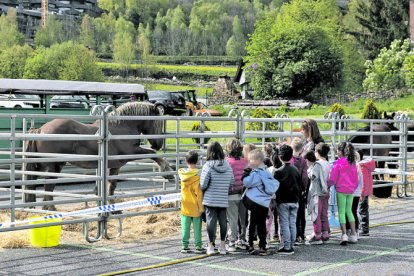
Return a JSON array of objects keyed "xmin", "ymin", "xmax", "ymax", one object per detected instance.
[{"xmin": 0, "ymin": 108, "xmax": 414, "ymax": 242}]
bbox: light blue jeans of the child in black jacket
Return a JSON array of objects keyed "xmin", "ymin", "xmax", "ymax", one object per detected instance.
[{"xmin": 277, "ymin": 203, "xmax": 299, "ymax": 249}]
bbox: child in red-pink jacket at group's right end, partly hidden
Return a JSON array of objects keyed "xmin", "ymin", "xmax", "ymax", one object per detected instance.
[{"xmin": 358, "ymin": 150, "xmax": 375, "ymax": 236}]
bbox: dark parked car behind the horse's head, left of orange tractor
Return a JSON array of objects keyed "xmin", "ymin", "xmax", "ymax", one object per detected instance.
[{"xmin": 148, "ymin": 90, "xmax": 187, "ymax": 115}]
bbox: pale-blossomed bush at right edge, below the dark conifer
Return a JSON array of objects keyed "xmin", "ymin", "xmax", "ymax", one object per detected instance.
[{"xmin": 363, "ymin": 39, "xmax": 411, "ymax": 91}]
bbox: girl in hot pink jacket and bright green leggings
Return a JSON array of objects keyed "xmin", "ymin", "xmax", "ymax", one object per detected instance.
[{"xmin": 329, "ymin": 142, "xmax": 358, "ymax": 245}]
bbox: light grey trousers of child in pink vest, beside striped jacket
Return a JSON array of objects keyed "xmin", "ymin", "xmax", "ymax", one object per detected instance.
[{"xmin": 227, "ymin": 200, "xmax": 246, "ymax": 244}]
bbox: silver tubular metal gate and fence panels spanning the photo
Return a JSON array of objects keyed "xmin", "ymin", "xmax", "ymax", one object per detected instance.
[{"xmin": 0, "ymin": 108, "xmax": 414, "ymax": 242}]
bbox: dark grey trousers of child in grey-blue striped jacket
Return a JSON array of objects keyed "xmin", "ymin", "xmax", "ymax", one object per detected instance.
[{"xmin": 204, "ymin": 206, "xmax": 227, "ymax": 243}]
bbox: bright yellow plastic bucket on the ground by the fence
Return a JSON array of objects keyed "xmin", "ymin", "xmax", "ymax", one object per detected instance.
[{"xmin": 29, "ymin": 217, "xmax": 62, "ymax": 247}]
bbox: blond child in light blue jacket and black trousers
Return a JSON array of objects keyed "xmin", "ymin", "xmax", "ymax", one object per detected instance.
[{"xmin": 243, "ymin": 150, "xmax": 279, "ymax": 255}]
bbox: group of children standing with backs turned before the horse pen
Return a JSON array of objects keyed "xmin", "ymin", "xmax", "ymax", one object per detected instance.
[{"xmin": 178, "ymin": 135, "xmax": 375, "ymax": 255}]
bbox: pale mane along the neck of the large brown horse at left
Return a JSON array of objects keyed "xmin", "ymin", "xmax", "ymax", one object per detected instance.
[{"xmin": 109, "ymin": 102, "xmax": 160, "ymax": 125}]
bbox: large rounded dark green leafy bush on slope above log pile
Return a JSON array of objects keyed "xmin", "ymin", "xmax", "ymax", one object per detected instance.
[{"xmin": 247, "ymin": 27, "xmax": 343, "ymax": 99}]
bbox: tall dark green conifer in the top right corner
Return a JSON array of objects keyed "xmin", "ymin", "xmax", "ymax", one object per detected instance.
[{"xmin": 345, "ymin": 0, "xmax": 409, "ymax": 59}]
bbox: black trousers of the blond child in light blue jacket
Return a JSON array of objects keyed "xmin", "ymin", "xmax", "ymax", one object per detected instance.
[{"xmin": 249, "ymin": 199, "xmax": 269, "ymax": 249}]
